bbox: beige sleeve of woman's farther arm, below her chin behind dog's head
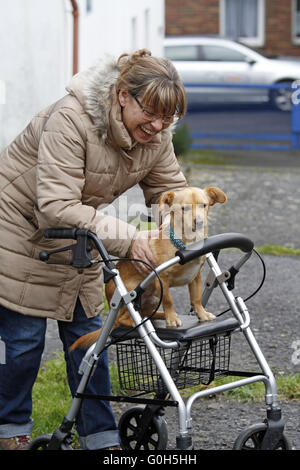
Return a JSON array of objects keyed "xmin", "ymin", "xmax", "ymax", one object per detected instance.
[{"xmin": 140, "ymin": 131, "xmax": 187, "ymax": 207}]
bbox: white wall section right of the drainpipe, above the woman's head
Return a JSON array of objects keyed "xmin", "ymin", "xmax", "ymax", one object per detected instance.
[{"xmin": 78, "ymin": 0, "xmax": 165, "ymax": 70}]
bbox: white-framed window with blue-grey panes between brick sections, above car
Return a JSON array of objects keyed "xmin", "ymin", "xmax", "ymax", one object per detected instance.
[{"xmin": 220, "ymin": 0, "xmax": 265, "ymax": 46}]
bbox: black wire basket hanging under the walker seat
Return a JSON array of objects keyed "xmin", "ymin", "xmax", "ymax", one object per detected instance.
[{"xmin": 117, "ymin": 333, "xmax": 231, "ymax": 393}]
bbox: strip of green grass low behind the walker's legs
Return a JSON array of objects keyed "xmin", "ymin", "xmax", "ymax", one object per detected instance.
[{"xmin": 32, "ymin": 353, "xmax": 300, "ymax": 438}]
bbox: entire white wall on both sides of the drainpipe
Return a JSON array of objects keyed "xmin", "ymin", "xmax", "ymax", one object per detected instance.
[{"xmin": 0, "ymin": 0, "xmax": 164, "ymax": 151}]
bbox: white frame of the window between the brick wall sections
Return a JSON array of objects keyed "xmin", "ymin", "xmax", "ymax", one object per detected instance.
[{"xmin": 219, "ymin": 0, "xmax": 266, "ymax": 47}]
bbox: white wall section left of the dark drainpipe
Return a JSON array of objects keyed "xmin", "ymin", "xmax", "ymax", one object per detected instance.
[{"xmin": 0, "ymin": 0, "xmax": 70, "ymax": 150}]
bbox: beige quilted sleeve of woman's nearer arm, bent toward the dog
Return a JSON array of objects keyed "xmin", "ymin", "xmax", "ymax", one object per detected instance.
[{"xmin": 36, "ymin": 108, "xmax": 136, "ymax": 257}]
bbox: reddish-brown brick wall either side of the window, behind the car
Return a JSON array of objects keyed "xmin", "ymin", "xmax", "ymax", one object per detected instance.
[{"xmin": 165, "ymin": 0, "xmax": 300, "ymax": 57}]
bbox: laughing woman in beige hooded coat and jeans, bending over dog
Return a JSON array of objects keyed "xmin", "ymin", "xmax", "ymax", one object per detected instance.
[{"xmin": 0, "ymin": 50, "xmax": 186, "ymax": 449}]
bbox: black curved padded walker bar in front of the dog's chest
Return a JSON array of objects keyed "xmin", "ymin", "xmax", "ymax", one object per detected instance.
[{"xmin": 176, "ymin": 233, "xmax": 254, "ymax": 264}]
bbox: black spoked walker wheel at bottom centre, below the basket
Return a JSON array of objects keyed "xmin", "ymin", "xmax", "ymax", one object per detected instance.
[{"xmin": 119, "ymin": 407, "xmax": 168, "ymax": 450}]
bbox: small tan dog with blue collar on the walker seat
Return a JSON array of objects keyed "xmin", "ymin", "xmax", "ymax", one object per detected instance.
[{"xmin": 70, "ymin": 186, "xmax": 226, "ymax": 350}]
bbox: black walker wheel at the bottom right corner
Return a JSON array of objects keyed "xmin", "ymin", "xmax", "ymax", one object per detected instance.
[{"xmin": 233, "ymin": 423, "xmax": 291, "ymax": 450}]
